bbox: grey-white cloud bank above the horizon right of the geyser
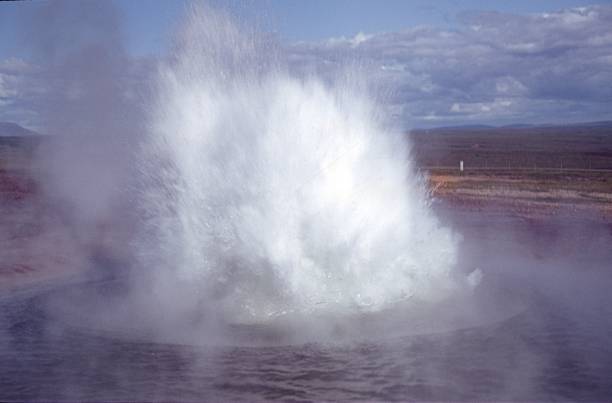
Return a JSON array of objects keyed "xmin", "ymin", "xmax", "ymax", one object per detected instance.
[{"xmin": 289, "ymin": 6, "xmax": 612, "ymax": 124}]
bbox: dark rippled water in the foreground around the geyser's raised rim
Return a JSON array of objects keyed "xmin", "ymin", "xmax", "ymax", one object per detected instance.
[{"xmin": 0, "ymin": 213, "xmax": 612, "ymax": 401}]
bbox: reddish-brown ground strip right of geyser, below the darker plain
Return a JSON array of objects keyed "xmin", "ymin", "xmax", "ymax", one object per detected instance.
[{"xmin": 428, "ymin": 169, "xmax": 612, "ymax": 222}]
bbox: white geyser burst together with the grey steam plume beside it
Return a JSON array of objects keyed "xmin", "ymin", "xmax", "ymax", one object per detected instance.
[{"xmin": 15, "ymin": 3, "xmax": 488, "ymax": 344}]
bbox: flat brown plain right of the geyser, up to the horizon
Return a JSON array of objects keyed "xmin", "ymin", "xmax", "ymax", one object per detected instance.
[{"xmin": 411, "ymin": 126, "xmax": 612, "ymax": 222}]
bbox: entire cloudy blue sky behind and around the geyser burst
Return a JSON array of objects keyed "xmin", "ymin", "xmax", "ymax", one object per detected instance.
[{"xmin": 0, "ymin": 0, "xmax": 612, "ymax": 128}]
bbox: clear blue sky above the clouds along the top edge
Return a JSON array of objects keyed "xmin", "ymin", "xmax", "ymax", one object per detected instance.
[{"xmin": 89, "ymin": 0, "xmax": 612, "ymax": 54}]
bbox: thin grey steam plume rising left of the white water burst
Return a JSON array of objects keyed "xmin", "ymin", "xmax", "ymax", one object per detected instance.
[{"xmin": 22, "ymin": 2, "xmax": 149, "ymax": 253}]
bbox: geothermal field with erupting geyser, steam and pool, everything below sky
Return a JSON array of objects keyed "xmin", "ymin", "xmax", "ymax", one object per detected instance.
[{"xmin": 0, "ymin": 1, "xmax": 612, "ymax": 401}]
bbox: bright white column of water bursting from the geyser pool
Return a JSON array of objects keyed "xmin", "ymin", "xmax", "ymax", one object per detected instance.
[{"xmin": 134, "ymin": 7, "xmax": 457, "ymax": 321}]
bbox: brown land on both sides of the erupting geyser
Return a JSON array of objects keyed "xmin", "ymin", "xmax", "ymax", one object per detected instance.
[{"xmin": 0, "ymin": 125, "xmax": 612, "ymax": 289}]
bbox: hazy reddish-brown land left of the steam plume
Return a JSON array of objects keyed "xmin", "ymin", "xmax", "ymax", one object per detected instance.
[{"xmin": 0, "ymin": 136, "xmax": 87, "ymax": 290}]
